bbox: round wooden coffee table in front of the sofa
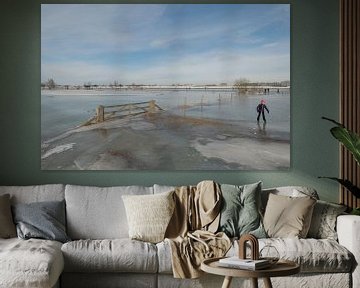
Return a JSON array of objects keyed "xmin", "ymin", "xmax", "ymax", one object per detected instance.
[{"xmin": 201, "ymin": 258, "xmax": 300, "ymax": 288}]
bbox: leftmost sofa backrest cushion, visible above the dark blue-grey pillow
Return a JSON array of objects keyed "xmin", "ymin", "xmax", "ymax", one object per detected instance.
[{"xmin": 0, "ymin": 184, "xmax": 65, "ymax": 204}]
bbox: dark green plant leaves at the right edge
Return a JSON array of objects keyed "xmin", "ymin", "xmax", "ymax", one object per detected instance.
[{"xmin": 320, "ymin": 117, "xmax": 360, "ymax": 215}]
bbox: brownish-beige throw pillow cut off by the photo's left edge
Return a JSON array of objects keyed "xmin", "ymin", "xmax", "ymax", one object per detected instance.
[{"xmin": 0, "ymin": 194, "xmax": 16, "ymax": 238}]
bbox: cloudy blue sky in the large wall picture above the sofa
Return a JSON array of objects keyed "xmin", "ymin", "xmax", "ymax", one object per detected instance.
[{"xmin": 41, "ymin": 4, "xmax": 290, "ymax": 85}]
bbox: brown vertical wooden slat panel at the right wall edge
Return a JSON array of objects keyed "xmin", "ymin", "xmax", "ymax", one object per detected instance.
[{"xmin": 340, "ymin": 0, "xmax": 360, "ymax": 208}]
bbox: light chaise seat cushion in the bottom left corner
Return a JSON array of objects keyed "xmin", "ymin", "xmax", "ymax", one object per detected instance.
[{"xmin": 0, "ymin": 238, "xmax": 64, "ymax": 288}]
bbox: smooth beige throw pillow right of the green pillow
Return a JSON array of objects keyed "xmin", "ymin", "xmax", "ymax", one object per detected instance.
[{"xmin": 264, "ymin": 194, "xmax": 316, "ymax": 238}]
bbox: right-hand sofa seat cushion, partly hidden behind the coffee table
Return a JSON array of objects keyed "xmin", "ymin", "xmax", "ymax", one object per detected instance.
[{"xmin": 157, "ymin": 238, "xmax": 355, "ymax": 274}]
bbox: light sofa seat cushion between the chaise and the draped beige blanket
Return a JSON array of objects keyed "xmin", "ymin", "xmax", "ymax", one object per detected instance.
[{"xmin": 61, "ymin": 238, "xmax": 158, "ymax": 273}]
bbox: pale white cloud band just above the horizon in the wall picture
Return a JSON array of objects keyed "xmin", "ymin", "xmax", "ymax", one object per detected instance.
[{"xmin": 42, "ymin": 42, "xmax": 290, "ymax": 84}]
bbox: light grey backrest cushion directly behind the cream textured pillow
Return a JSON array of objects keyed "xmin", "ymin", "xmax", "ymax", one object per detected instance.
[{"xmin": 65, "ymin": 185, "xmax": 154, "ymax": 240}]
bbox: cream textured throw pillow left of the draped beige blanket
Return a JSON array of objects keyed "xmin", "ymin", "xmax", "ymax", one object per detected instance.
[{"xmin": 122, "ymin": 191, "xmax": 175, "ymax": 243}]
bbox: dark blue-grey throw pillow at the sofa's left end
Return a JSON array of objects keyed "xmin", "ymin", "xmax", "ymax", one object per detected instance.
[{"xmin": 13, "ymin": 201, "xmax": 70, "ymax": 243}]
